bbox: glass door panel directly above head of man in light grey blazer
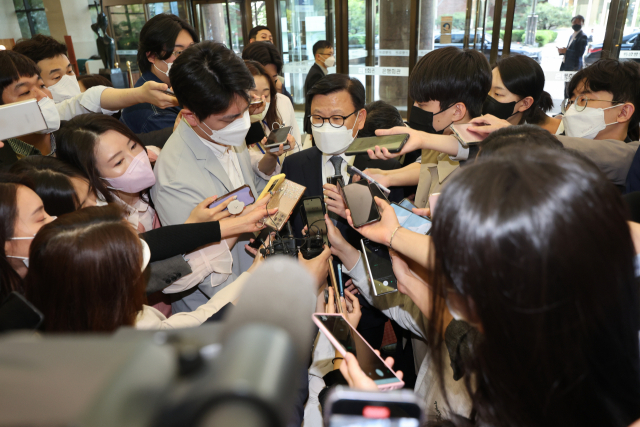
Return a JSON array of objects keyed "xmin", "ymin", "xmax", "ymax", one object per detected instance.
[{"xmin": 193, "ymin": 1, "xmax": 249, "ymax": 55}]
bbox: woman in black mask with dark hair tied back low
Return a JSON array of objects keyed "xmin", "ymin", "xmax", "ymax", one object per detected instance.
[{"xmin": 482, "ymin": 55, "xmax": 561, "ymax": 134}]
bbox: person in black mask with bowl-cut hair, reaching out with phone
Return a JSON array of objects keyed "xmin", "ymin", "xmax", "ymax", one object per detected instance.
[{"xmin": 364, "ymin": 46, "xmax": 491, "ymax": 214}]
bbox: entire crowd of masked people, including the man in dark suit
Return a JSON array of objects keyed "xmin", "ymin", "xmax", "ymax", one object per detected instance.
[{"xmin": 0, "ymin": 14, "xmax": 640, "ymax": 427}]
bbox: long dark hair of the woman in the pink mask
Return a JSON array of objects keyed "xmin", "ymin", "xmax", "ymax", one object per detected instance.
[{"xmin": 56, "ymin": 113, "xmax": 151, "ymax": 204}]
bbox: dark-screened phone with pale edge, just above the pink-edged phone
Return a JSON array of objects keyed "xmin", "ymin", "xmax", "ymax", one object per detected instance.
[{"xmin": 360, "ymin": 239, "xmax": 398, "ymax": 296}]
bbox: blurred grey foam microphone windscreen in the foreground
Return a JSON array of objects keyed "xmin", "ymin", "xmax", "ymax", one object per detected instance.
[{"xmin": 222, "ymin": 256, "xmax": 316, "ymax": 360}]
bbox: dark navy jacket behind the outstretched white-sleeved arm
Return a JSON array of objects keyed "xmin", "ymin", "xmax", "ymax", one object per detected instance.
[{"xmin": 120, "ymin": 71, "xmax": 180, "ymax": 133}]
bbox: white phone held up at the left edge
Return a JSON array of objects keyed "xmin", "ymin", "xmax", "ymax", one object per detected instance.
[{"xmin": 0, "ymin": 99, "xmax": 47, "ymax": 141}]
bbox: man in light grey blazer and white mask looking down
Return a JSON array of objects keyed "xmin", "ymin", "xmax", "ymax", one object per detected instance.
[{"xmin": 151, "ymin": 41, "xmax": 278, "ymax": 312}]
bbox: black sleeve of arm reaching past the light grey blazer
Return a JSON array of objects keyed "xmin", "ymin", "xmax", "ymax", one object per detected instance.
[{"xmin": 140, "ymin": 221, "xmax": 222, "ymax": 262}]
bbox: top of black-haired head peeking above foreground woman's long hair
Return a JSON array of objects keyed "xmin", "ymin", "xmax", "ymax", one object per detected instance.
[{"xmin": 478, "ymin": 124, "xmax": 564, "ymax": 157}]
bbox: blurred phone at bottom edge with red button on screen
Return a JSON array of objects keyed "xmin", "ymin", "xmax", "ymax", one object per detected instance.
[{"xmin": 323, "ymin": 386, "xmax": 424, "ymax": 427}]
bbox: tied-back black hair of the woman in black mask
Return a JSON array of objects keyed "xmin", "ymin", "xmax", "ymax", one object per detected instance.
[{"xmin": 494, "ymin": 55, "xmax": 553, "ymax": 124}]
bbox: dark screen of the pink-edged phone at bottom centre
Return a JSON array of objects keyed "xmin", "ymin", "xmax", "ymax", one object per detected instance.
[{"xmin": 314, "ymin": 314, "xmax": 398, "ymax": 385}]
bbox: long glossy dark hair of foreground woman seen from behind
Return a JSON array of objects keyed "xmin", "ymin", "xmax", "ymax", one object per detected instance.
[{"xmin": 428, "ymin": 147, "xmax": 640, "ymax": 427}]
